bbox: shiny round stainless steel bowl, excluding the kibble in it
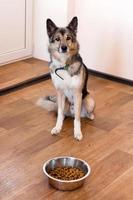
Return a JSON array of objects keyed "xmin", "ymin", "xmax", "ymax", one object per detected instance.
[{"xmin": 43, "ymin": 156, "xmax": 90, "ymax": 190}]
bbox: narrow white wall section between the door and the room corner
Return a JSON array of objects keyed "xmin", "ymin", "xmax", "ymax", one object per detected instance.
[{"xmin": 33, "ymin": 0, "xmax": 68, "ymax": 60}]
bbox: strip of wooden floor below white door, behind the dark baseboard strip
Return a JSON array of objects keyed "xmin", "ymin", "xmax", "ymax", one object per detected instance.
[{"xmin": 0, "ymin": 58, "xmax": 49, "ymax": 91}]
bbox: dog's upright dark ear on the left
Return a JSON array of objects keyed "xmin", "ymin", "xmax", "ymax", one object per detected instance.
[{"xmin": 46, "ymin": 19, "xmax": 57, "ymax": 37}]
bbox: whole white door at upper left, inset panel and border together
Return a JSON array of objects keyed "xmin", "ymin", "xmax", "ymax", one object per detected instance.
[{"xmin": 0, "ymin": 0, "xmax": 32, "ymax": 64}]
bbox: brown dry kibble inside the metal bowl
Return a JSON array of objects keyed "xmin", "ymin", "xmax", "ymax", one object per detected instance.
[{"xmin": 49, "ymin": 167, "xmax": 85, "ymax": 181}]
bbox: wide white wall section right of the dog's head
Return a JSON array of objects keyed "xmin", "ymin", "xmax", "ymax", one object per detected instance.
[{"xmin": 75, "ymin": 0, "xmax": 133, "ymax": 80}]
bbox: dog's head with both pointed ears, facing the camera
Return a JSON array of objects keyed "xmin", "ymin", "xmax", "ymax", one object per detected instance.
[{"xmin": 46, "ymin": 17, "xmax": 79, "ymax": 54}]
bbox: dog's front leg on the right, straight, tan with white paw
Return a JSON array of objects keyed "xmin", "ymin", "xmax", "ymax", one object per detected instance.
[{"xmin": 74, "ymin": 91, "xmax": 83, "ymax": 140}]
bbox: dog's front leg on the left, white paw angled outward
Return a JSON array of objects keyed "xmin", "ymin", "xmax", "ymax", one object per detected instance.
[{"xmin": 51, "ymin": 91, "xmax": 65, "ymax": 135}]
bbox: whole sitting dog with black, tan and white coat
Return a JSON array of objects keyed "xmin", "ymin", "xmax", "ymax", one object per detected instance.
[{"xmin": 37, "ymin": 17, "xmax": 95, "ymax": 140}]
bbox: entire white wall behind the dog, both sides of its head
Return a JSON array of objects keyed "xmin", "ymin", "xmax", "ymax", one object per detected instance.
[{"xmin": 33, "ymin": 0, "xmax": 133, "ymax": 80}]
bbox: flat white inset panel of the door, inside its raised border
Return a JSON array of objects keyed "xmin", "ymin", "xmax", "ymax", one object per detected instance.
[{"xmin": 0, "ymin": 0, "xmax": 26, "ymax": 54}]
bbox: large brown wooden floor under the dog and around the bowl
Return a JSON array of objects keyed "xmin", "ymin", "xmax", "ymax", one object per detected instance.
[{"xmin": 0, "ymin": 76, "xmax": 133, "ymax": 200}]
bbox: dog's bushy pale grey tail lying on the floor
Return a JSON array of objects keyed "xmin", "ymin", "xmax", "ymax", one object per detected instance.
[{"xmin": 37, "ymin": 96, "xmax": 57, "ymax": 111}]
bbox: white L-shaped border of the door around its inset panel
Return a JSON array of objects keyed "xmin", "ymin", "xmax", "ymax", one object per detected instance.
[{"xmin": 0, "ymin": 0, "xmax": 33, "ymax": 65}]
